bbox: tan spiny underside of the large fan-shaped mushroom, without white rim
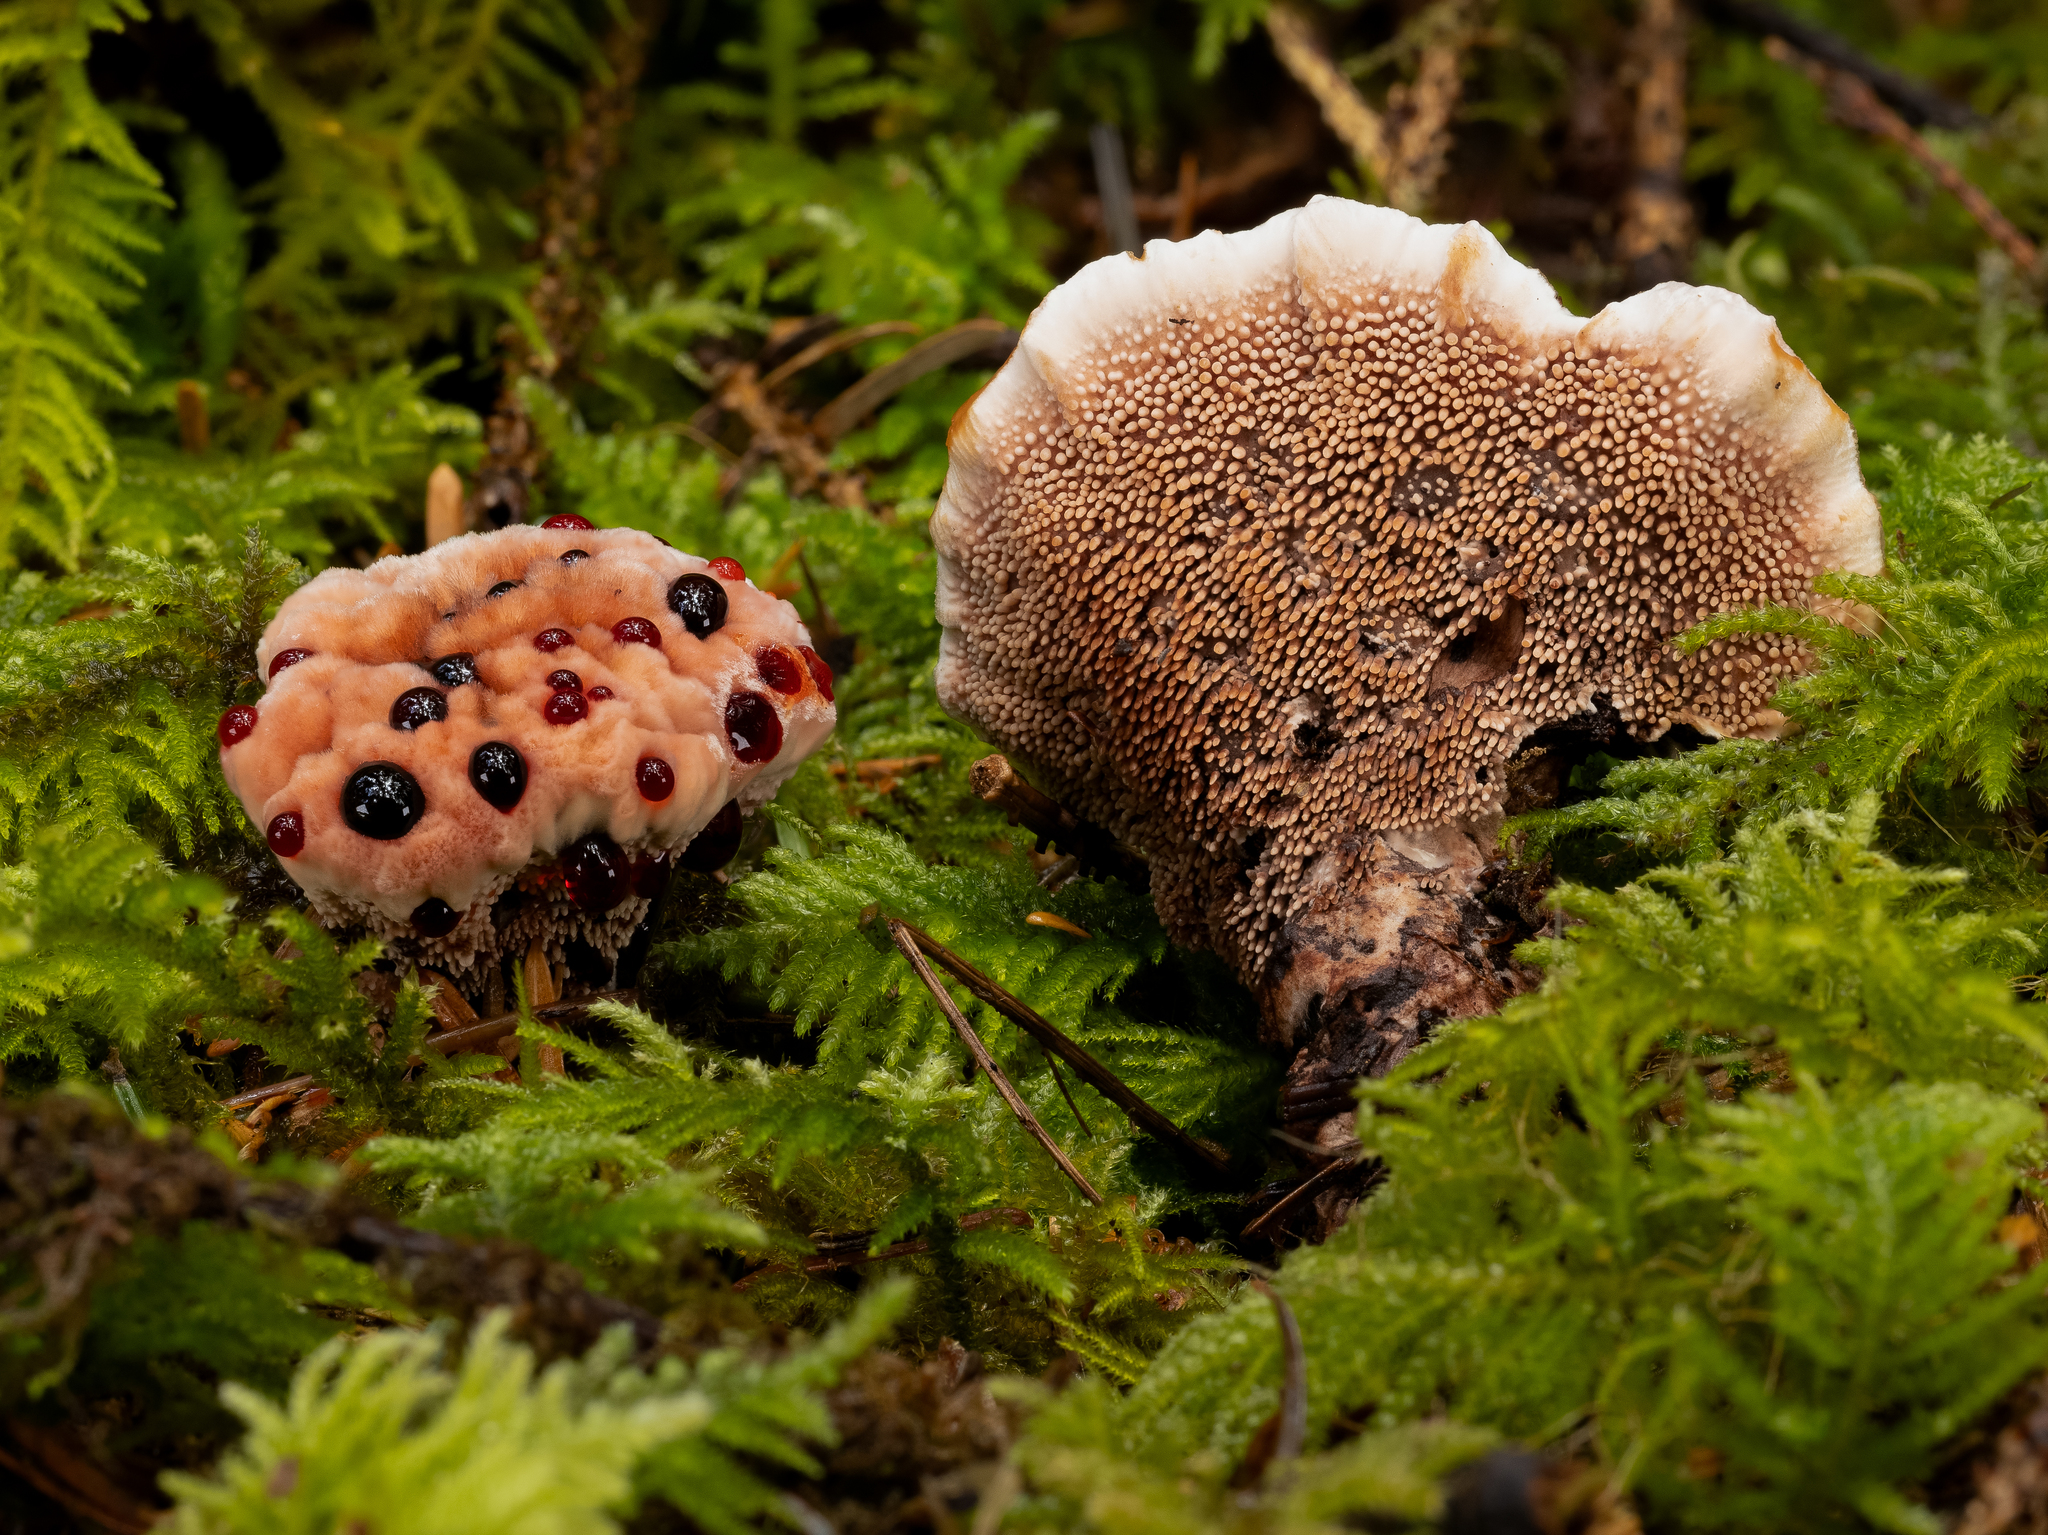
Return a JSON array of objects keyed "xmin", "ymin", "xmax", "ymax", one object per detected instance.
[{"xmin": 940, "ymin": 201, "xmax": 1868, "ymax": 974}]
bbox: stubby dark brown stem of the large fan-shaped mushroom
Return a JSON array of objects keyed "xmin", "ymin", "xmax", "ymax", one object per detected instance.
[{"xmin": 1260, "ymin": 819, "xmax": 1534, "ymax": 1142}]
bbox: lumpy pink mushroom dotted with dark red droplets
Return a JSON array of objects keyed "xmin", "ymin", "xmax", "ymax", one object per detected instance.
[{"xmin": 219, "ymin": 518, "xmax": 834, "ymax": 970}]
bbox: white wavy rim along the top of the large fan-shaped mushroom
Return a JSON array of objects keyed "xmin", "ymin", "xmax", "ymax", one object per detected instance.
[{"xmin": 932, "ymin": 196, "xmax": 1884, "ymax": 732}]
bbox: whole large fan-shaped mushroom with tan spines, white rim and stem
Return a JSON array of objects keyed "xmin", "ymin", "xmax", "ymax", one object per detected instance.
[{"xmin": 932, "ymin": 199, "xmax": 1882, "ymax": 1146}]
